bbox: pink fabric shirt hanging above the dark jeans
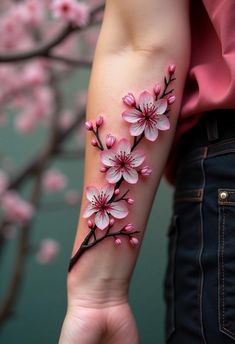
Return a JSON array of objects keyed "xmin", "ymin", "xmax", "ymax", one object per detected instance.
[{"xmin": 165, "ymin": 0, "xmax": 235, "ymax": 184}]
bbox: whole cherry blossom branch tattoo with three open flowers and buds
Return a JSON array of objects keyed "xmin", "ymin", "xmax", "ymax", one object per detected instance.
[{"xmin": 69, "ymin": 64, "xmax": 176, "ymax": 271}]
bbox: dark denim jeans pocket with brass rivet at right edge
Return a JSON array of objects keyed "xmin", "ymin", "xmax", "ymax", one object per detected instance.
[{"xmin": 218, "ymin": 189, "xmax": 235, "ymax": 340}]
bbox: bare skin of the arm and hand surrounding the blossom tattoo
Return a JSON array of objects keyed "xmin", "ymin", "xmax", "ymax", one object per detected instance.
[{"xmin": 59, "ymin": 0, "xmax": 190, "ymax": 344}]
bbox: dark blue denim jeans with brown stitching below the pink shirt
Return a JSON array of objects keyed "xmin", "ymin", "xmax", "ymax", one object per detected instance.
[{"xmin": 164, "ymin": 139, "xmax": 235, "ymax": 344}]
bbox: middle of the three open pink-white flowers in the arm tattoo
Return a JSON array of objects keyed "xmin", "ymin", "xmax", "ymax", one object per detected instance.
[{"xmin": 100, "ymin": 139, "xmax": 145, "ymax": 184}]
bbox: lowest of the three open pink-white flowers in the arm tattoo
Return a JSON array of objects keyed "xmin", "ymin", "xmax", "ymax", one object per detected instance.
[{"xmin": 83, "ymin": 184, "xmax": 128, "ymax": 229}]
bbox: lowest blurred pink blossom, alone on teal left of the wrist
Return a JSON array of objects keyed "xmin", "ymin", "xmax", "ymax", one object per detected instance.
[{"xmin": 36, "ymin": 238, "xmax": 60, "ymax": 264}]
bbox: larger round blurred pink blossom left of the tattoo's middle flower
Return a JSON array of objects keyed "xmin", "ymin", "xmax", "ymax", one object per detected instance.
[{"xmin": 42, "ymin": 169, "xmax": 67, "ymax": 192}]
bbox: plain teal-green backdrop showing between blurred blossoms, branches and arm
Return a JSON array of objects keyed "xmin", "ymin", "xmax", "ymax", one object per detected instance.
[{"xmin": 0, "ymin": 71, "xmax": 172, "ymax": 344}]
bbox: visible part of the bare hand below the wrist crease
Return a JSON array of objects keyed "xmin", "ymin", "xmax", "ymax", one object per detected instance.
[{"xmin": 59, "ymin": 302, "xmax": 139, "ymax": 344}]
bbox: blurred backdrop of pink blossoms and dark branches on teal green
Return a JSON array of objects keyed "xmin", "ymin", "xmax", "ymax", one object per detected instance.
[{"xmin": 0, "ymin": 0, "xmax": 172, "ymax": 344}]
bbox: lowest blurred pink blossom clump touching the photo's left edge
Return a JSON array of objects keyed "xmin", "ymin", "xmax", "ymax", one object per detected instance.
[{"xmin": 1, "ymin": 191, "xmax": 34, "ymax": 223}]
